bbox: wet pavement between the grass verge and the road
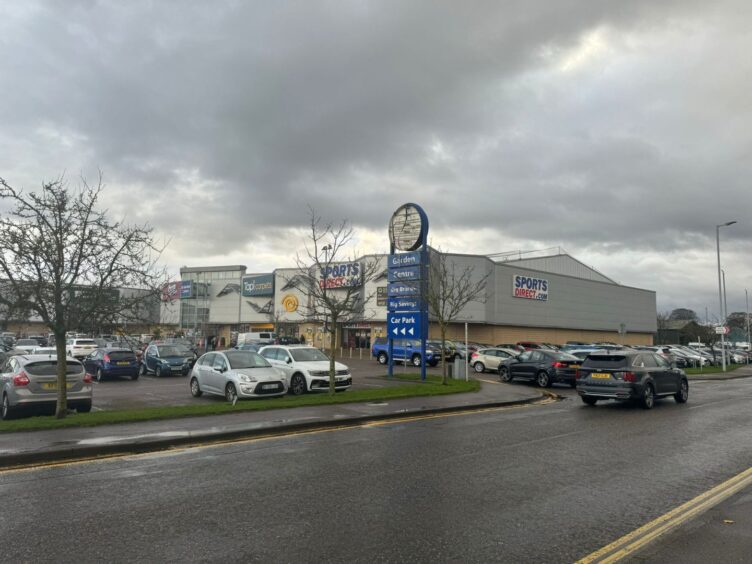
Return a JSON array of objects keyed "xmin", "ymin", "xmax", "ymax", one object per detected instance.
[{"xmin": 0, "ymin": 374, "xmax": 544, "ymax": 468}]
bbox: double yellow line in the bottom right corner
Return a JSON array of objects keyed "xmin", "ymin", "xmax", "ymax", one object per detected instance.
[{"xmin": 577, "ymin": 468, "xmax": 752, "ymax": 564}]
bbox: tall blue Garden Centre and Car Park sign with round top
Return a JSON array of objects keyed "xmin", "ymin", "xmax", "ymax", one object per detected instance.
[{"xmin": 386, "ymin": 204, "xmax": 429, "ymax": 380}]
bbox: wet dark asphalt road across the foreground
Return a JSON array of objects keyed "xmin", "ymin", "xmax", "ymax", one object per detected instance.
[{"xmin": 0, "ymin": 379, "xmax": 752, "ymax": 562}]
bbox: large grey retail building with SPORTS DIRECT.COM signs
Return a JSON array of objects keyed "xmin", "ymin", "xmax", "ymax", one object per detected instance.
[{"xmin": 160, "ymin": 253, "xmax": 657, "ymax": 348}]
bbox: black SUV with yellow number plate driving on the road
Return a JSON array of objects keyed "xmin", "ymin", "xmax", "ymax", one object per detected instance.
[{"xmin": 577, "ymin": 351, "xmax": 689, "ymax": 409}]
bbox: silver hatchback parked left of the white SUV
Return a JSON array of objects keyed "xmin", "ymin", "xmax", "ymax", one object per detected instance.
[{"xmin": 190, "ymin": 350, "xmax": 287, "ymax": 403}]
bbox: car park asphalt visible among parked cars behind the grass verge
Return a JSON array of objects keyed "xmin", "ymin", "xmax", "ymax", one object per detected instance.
[{"xmin": 94, "ymin": 351, "xmax": 458, "ymax": 411}]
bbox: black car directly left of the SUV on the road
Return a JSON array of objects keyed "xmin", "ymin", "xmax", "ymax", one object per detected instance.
[{"xmin": 499, "ymin": 349, "xmax": 582, "ymax": 388}]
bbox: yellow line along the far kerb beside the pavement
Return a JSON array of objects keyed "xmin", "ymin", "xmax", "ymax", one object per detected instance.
[{"xmin": 0, "ymin": 394, "xmax": 556, "ymax": 475}]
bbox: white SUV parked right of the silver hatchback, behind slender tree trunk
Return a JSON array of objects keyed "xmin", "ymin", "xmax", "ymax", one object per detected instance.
[{"xmin": 259, "ymin": 345, "xmax": 352, "ymax": 396}]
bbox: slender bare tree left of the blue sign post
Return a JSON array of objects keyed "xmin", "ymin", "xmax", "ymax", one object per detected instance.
[{"xmin": 293, "ymin": 207, "xmax": 379, "ymax": 395}]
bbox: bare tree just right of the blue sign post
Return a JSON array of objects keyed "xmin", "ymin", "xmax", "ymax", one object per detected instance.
[{"xmin": 426, "ymin": 251, "xmax": 489, "ymax": 384}]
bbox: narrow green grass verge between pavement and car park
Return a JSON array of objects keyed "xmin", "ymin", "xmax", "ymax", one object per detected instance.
[{"xmin": 0, "ymin": 374, "xmax": 480, "ymax": 433}]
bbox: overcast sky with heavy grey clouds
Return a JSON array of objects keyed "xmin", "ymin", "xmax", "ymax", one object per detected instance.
[{"xmin": 0, "ymin": 0, "xmax": 752, "ymax": 319}]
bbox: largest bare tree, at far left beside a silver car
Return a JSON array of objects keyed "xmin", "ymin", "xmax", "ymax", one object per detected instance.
[{"xmin": 0, "ymin": 174, "xmax": 166, "ymax": 418}]
